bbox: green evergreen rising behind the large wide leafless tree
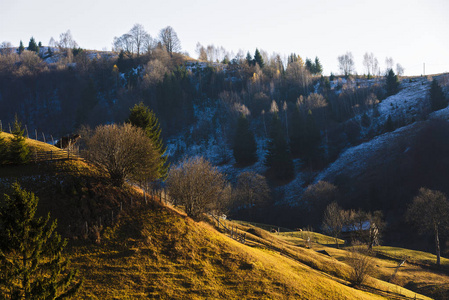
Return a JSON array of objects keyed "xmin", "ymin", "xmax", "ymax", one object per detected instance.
[{"xmin": 126, "ymin": 102, "xmax": 168, "ymax": 179}]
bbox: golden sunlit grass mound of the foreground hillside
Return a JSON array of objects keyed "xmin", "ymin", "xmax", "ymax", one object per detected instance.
[{"xmin": 70, "ymin": 204, "xmax": 388, "ymax": 299}]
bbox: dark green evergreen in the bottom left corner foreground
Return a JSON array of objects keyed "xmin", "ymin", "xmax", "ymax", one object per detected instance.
[{"xmin": 0, "ymin": 183, "xmax": 81, "ymax": 299}]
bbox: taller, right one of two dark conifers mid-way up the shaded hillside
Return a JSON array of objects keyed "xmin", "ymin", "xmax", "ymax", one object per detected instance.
[{"xmin": 265, "ymin": 112, "xmax": 295, "ymax": 179}]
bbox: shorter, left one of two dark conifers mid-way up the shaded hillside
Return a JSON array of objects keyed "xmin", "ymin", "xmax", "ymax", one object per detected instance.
[{"xmin": 232, "ymin": 114, "xmax": 257, "ymax": 165}]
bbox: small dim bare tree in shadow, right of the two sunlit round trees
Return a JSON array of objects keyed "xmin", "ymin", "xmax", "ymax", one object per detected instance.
[{"xmin": 236, "ymin": 172, "xmax": 270, "ymax": 217}]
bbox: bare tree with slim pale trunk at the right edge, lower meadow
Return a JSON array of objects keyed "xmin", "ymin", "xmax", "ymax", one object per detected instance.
[{"xmin": 406, "ymin": 188, "xmax": 449, "ymax": 265}]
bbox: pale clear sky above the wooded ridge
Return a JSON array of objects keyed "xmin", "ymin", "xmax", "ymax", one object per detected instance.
[{"xmin": 0, "ymin": 0, "xmax": 449, "ymax": 75}]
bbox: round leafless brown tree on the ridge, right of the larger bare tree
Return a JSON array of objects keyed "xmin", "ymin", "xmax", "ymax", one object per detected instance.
[{"xmin": 167, "ymin": 157, "xmax": 229, "ymax": 218}]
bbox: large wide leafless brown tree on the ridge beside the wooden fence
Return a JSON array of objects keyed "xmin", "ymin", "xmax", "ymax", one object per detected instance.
[{"xmin": 83, "ymin": 124, "xmax": 160, "ymax": 186}]
